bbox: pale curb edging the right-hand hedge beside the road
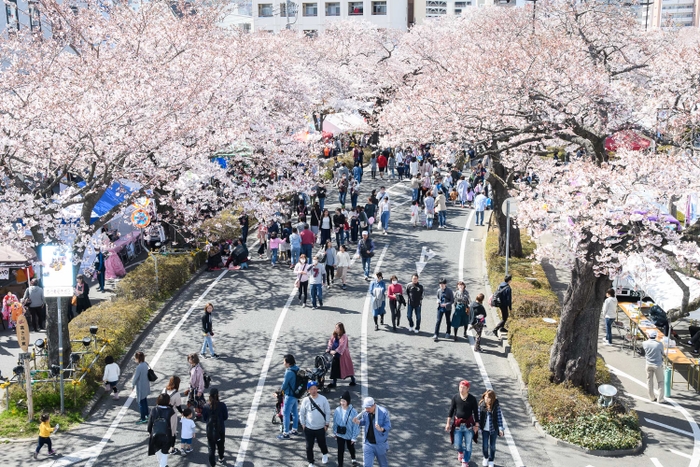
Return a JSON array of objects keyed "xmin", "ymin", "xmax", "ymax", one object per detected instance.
[{"xmin": 483, "ymin": 232, "xmax": 646, "ymax": 457}]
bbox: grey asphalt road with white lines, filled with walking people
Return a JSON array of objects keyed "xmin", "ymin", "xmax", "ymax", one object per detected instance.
[{"xmin": 16, "ymin": 172, "xmax": 700, "ymax": 467}]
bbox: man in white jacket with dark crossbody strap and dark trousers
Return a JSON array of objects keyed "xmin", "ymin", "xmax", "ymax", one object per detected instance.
[{"xmin": 299, "ymin": 381, "xmax": 331, "ymax": 467}]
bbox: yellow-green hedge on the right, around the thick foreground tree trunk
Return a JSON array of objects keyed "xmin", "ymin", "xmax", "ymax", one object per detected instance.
[{"xmin": 485, "ymin": 230, "xmax": 641, "ymax": 450}]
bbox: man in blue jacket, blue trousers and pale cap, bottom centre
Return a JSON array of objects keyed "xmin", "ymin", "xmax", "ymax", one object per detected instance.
[{"xmin": 352, "ymin": 397, "xmax": 391, "ymax": 467}]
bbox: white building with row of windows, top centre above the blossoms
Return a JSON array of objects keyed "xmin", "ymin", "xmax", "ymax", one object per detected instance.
[{"xmin": 253, "ymin": 0, "xmax": 413, "ymax": 36}]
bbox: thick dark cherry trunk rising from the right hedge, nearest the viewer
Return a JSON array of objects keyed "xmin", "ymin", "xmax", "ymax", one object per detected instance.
[{"xmin": 549, "ymin": 254, "xmax": 611, "ymax": 394}]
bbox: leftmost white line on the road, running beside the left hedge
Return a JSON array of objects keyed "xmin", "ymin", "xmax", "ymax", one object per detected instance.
[{"xmin": 45, "ymin": 270, "xmax": 228, "ymax": 467}]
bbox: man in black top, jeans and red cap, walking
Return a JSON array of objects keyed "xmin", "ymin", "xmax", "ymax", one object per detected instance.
[{"xmin": 445, "ymin": 380, "xmax": 479, "ymax": 467}]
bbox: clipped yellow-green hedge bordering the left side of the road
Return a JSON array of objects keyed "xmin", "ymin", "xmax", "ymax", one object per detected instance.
[{"xmin": 0, "ymin": 251, "xmax": 206, "ymax": 437}]
